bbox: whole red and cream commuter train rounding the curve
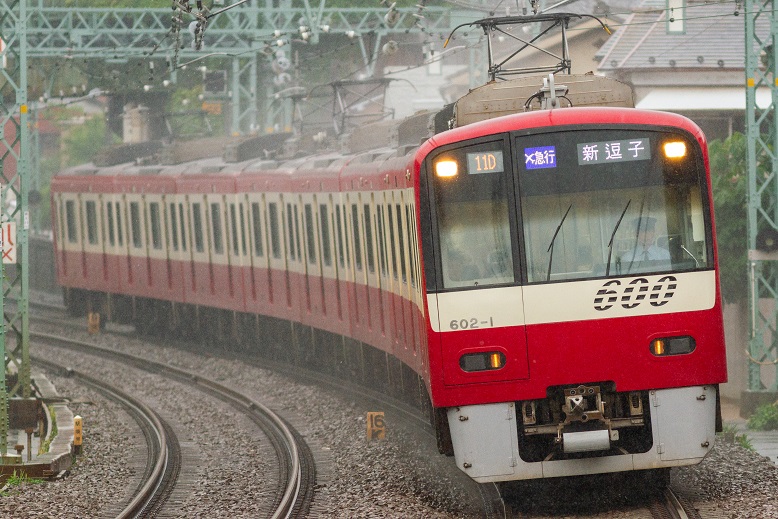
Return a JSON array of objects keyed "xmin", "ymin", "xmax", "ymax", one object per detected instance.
[{"xmin": 52, "ymin": 66, "xmax": 727, "ymax": 488}]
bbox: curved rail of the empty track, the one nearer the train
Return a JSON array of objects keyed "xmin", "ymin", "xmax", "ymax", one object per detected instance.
[{"xmin": 30, "ymin": 332, "xmax": 315, "ymax": 518}]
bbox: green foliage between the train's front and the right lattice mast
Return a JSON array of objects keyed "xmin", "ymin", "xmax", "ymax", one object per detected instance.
[{"xmin": 708, "ymin": 133, "xmax": 748, "ymax": 303}]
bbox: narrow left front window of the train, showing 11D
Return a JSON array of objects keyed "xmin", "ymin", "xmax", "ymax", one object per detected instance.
[{"xmin": 428, "ymin": 139, "xmax": 515, "ymax": 289}]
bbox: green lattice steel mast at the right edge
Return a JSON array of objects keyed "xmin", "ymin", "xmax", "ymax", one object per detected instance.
[{"xmin": 741, "ymin": 0, "xmax": 778, "ymax": 411}]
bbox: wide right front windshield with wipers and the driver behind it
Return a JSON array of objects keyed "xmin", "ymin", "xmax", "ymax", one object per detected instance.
[{"xmin": 515, "ymin": 127, "xmax": 712, "ymax": 283}]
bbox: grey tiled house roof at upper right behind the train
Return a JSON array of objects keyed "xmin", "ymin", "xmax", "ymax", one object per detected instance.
[{"xmin": 598, "ymin": 0, "xmax": 752, "ymax": 72}]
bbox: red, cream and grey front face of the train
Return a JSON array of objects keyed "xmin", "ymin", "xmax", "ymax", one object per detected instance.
[{"xmin": 418, "ymin": 108, "xmax": 726, "ymax": 482}]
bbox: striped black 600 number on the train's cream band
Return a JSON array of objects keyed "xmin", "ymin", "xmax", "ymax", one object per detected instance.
[{"xmin": 594, "ymin": 276, "xmax": 678, "ymax": 312}]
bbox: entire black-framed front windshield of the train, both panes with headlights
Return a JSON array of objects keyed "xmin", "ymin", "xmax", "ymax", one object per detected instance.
[{"xmin": 428, "ymin": 127, "xmax": 712, "ymax": 289}]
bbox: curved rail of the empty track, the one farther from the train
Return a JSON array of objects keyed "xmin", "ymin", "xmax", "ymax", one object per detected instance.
[{"xmin": 31, "ymin": 356, "xmax": 181, "ymax": 519}]
